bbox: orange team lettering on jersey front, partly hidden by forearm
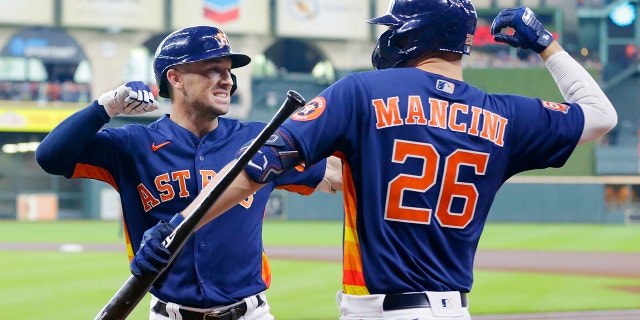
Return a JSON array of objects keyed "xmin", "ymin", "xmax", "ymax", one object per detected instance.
[{"xmin": 138, "ymin": 170, "xmax": 253, "ymax": 212}]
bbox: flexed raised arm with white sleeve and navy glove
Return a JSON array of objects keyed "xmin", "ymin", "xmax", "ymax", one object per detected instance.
[{"xmin": 491, "ymin": 7, "xmax": 618, "ymax": 144}]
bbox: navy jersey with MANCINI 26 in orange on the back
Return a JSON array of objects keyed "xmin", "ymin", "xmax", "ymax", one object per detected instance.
[{"xmin": 283, "ymin": 68, "xmax": 584, "ymax": 294}]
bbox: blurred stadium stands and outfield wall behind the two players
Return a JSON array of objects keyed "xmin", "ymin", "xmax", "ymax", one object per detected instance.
[{"xmin": 0, "ymin": 0, "xmax": 640, "ymax": 224}]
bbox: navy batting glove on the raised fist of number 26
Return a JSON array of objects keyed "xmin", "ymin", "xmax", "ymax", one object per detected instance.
[{"xmin": 491, "ymin": 7, "xmax": 553, "ymax": 53}]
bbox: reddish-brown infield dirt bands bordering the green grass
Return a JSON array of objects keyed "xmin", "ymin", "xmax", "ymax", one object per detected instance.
[{"xmin": 5, "ymin": 243, "xmax": 640, "ymax": 320}]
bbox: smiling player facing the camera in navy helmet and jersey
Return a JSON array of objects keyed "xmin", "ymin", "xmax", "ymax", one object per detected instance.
[{"xmin": 36, "ymin": 26, "xmax": 340, "ymax": 320}]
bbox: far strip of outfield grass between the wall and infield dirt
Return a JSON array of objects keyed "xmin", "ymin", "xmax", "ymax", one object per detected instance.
[{"xmin": 5, "ymin": 221, "xmax": 640, "ymax": 252}]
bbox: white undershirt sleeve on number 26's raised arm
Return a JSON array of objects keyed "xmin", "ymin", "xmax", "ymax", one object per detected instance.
[{"xmin": 545, "ymin": 51, "xmax": 618, "ymax": 144}]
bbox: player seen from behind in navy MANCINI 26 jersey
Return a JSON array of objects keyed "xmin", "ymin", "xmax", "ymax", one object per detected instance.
[{"xmin": 134, "ymin": 0, "xmax": 617, "ymax": 320}]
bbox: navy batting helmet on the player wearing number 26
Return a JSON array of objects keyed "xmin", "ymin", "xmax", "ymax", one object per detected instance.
[{"xmin": 367, "ymin": 0, "xmax": 478, "ymax": 69}]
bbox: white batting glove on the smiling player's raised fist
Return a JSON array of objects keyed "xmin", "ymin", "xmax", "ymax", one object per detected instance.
[{"xmin": 98, "ymin": 81, "xmax": 158, "ymax": 118}]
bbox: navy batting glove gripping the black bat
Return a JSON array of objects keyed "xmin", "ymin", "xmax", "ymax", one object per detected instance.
[{"xmin": 129, "ymin": 213, "xmax": 184, "ymax": 277}]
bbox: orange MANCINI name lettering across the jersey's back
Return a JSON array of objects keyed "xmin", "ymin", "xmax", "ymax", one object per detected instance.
[{"xmin": 371, "ymin": 96, "xmax": 509, "ymax": 147}]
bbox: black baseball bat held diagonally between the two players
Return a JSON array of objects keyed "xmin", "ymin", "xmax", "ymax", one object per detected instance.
[{"xmin": 94, "ymin": 90, "xmax": 305, "ymax": 320}]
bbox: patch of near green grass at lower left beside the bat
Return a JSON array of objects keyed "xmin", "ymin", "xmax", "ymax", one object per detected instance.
[{"xmin": 0, "ymin": 251, "xmax": 149, "ymax": 320}]
